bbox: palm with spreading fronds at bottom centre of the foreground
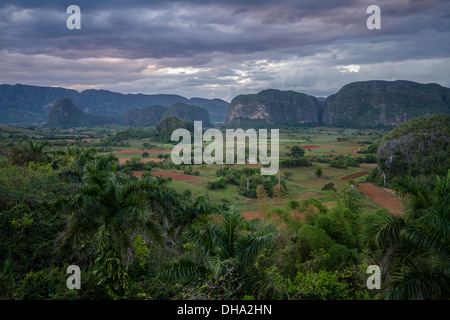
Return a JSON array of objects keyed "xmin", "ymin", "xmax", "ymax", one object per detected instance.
[{"xmin": 160, "ymin": 208, "xmax": 277, "ymax": 294}]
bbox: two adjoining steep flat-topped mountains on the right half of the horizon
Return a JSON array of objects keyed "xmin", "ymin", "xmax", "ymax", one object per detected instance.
[{"xmin": 225, "ymin": 80, "xmax": 450, "ymax": 128}]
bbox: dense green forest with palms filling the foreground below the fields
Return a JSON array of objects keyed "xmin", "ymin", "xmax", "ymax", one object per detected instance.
[{"xmin": 0, "ymin": 123, "xmax": 450, "ymax": 300}]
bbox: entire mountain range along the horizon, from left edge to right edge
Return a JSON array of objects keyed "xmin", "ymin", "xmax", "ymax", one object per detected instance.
[{"xmin": 0, "ymin": 80, "xmax": 450, "ymax": 128}]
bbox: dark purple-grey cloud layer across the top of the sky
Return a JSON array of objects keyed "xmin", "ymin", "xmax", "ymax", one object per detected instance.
[{"xmin": 0, "ymin": 0, "xmax": 450, "ymax": 59}]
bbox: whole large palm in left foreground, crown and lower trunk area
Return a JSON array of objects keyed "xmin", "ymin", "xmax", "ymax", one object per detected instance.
[{"xmin": 58, "ymin": 156, "xmax": 161, "ymax": 297}]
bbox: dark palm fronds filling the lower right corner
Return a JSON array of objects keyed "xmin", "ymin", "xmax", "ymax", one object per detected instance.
[{"xmin": 369, "ymin": 173, "xmax": 450, "ymax": 299}]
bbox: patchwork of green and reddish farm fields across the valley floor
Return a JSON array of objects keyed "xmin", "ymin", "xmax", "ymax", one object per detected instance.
[{"xmin": 0, "ymin": 126, "xmax": 398, "ymax": 217}]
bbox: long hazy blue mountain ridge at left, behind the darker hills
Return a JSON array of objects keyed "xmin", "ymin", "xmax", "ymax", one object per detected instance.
[{"xmin": 0, "ymin": 84, "xmax": 228, "ymax": 124}]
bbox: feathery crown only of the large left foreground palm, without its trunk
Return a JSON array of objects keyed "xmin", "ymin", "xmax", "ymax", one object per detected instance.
[{"xmin": 60, "ymin": 160, "xmax": 162, "ymax": 262}]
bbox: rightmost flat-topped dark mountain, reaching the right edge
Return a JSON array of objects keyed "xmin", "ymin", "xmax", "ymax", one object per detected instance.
[{"xmin": 322, "ymin": 80, "xmax": 450, "ymax": 127}]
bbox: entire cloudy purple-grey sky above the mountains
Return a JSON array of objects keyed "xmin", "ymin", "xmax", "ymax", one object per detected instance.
[{"xmin": 0, "ymin": 0, "xmax": 450, "ymax": 101}]
